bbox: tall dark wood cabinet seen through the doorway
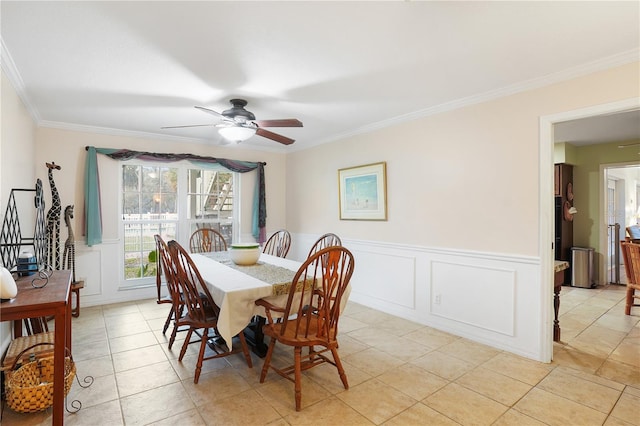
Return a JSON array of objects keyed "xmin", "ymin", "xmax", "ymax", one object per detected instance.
[{"xmin": 554, "ymin": 163, "xmax": 573, "ymax": 284}]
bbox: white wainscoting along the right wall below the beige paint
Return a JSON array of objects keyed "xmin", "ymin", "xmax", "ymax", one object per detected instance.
[{"xmin": 289, "ymin": 234, "xmax": 553, "ymax": 361}]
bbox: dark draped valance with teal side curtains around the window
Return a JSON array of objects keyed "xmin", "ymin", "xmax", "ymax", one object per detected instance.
[{"xmin": 84, "ymin": 146, "xmax": 267, "ymax": 246}]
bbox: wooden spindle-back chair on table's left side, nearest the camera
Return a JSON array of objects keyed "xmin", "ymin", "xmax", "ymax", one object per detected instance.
[{"xmin": 168, "ymin": 241, "xmax": 253, "ymax": 383}]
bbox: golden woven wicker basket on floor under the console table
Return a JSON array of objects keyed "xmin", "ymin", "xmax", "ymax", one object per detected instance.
[{"xmin": 5, "ymin": 343, "xmax": 76, "ymax": 413}]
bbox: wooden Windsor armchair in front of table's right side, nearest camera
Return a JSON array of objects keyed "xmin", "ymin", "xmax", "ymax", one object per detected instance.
[{"xmin": 256, "ymin": 246, "xmax": 354, "ymax": 411}]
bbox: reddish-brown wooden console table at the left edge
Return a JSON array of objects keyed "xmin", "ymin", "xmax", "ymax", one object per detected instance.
[{"xmin": 0, "ymin": 270, "xmax": 71, "ymax": 426}]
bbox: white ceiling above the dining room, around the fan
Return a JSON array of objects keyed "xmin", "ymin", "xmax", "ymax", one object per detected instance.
[{"xmin": 0, "ymin": 0, "xmax": 640, "ymax": 151}]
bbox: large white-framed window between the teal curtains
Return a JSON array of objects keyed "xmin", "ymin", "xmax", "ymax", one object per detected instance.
[{"xmin": 122, "ymin": 163, "xmax": 237, "ymax": 286}]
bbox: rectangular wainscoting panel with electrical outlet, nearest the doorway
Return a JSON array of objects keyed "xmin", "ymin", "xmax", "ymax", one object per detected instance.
[{"xmin": 430, "ymin": 261, "xmax": 515, "ymax": 336}]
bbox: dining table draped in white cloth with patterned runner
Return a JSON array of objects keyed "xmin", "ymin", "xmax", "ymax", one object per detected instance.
[{"xmin": 191, "ymin": 251, "xmax": 309, "ymax": 357}]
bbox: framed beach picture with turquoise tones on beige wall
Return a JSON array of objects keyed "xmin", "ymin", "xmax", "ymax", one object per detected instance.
[{"xmin": 338, "ymin": 162, "xmax": 387, "ymax": 220}]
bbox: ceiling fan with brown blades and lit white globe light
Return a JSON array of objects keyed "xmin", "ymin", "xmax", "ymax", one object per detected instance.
[{"xmin": 162, "ymin": 99, "xmax": 302, "ymax": 145}]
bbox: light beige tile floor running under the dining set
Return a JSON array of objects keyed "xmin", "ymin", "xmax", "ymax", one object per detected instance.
[{"xmin": 2, "ymin": 286, "xmax": 640, "ymax": 426}]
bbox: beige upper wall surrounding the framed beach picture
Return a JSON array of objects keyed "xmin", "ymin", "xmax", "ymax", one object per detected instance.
[{"xmin": 287, "ymin": 63, "xmax": 640, "ymax": 256}]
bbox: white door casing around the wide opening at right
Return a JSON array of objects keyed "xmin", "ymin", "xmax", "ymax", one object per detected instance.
[{"xmin": 538, "ymin": 97, "xmax": 640, "ymax": 362}]
